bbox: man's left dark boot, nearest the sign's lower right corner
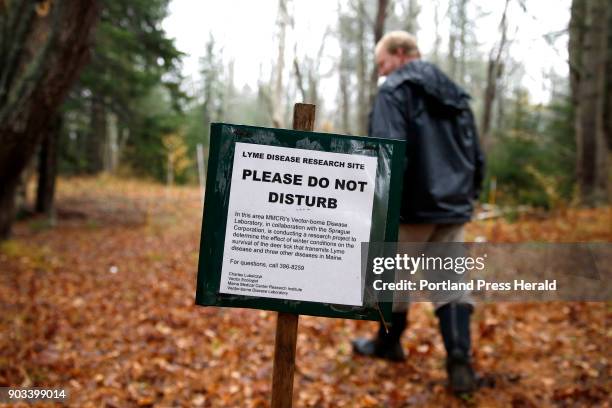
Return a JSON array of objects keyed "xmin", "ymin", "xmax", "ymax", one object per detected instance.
[{"xmin": 352, "ymin": 312, "xmax": 408, "ymax": 361}]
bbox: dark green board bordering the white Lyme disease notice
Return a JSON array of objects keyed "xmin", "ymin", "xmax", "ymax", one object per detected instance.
[{"xmin": 196, "ymin": 123, "xmax": 406, "ymax": 321}]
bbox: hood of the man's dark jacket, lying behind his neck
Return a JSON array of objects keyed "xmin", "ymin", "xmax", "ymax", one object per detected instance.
[{"xmin": 384, "ymin": 60, "xmax": 470, "ymax": 110}]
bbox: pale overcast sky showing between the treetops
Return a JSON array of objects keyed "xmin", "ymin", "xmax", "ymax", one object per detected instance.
[{"xmin": 163, "ymin": 0, "xmax": 570, "ymax": 108}]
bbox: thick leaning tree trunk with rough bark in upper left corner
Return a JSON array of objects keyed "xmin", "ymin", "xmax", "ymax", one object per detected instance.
[{"xmin": 0, "ymin": 0, "xmax": 99, "ymax": 239}]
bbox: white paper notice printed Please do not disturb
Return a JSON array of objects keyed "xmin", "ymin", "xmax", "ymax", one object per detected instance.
[{"xmin": 220, "ymin": 143, "xmax": 377, "ymax": 306}]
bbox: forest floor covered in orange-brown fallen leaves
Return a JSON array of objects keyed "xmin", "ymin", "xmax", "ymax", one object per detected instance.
[{"xmin": 0, "ymin": 177, "xmax": 612, "ymax": 407}]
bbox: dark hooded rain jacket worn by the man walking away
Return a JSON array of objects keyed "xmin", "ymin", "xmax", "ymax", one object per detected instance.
[{"xmin": 369, "ymin": 60, "xmax": 484, "ymax": 224}]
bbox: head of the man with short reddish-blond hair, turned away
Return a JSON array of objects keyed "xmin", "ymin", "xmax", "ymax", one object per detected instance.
[{"xmin": 375, "ymin": 31, "xmax": 421, "ymax": 76}]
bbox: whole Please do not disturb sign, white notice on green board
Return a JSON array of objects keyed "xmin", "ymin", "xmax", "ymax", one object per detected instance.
[{"xmin": 196, "ymin": 124, "xmax": 404, "ymax": 320}]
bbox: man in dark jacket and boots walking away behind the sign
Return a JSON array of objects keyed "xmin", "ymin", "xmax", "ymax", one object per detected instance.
[{"xmin": 353, "ymin": 31, "xmax": 484, "ymax": 393}]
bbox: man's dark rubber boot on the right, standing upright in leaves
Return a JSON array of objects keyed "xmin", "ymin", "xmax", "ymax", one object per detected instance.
[{"xmin": 436, "ymin": 303, "xmax": 476, "ymax": 394}]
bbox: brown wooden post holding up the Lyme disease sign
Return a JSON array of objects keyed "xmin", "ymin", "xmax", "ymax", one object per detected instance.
[{"xmin": 272, "ymin": 103, "xmax": 316, "ymax": 408}]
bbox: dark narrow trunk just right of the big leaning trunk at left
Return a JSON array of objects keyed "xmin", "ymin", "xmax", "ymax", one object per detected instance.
[{"xmin": 35, "ymin": 115, "xmax": 62, "ymax": 215}]
